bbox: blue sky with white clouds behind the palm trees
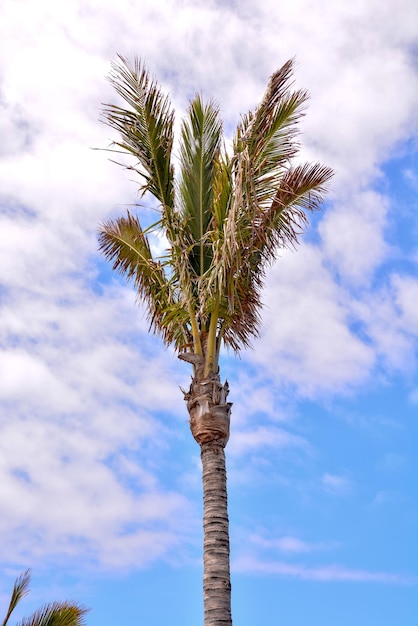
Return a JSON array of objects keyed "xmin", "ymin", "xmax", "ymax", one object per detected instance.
[{"xmin": 0, "ymin": 0, "xmax": 418, "ymax": 626}]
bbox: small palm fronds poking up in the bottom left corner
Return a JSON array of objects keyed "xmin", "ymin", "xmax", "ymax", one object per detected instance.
[{"xmin": 2, "ymin": 570, "xmax": 88, "ymax": 626}]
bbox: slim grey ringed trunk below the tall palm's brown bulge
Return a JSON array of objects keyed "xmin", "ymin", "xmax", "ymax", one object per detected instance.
[{"xmin": 200, "ymin": 442, "xmax": 232, "ymax": 626}]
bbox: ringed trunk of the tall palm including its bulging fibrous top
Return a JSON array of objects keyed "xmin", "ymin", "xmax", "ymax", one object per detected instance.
[{"xmin": 180, "ymin": 354, "xmax": 232, "ymax": 626}]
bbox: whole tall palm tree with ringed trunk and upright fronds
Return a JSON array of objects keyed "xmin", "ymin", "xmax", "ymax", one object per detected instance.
[{"xmin": 99, "ymin": 57, "xmax": 332, "ymax": 626}]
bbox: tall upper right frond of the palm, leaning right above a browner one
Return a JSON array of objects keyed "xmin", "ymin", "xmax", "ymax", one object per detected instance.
[{"xmin": 220, "ymin": 61, "xmax": 308, "ymax": 292}]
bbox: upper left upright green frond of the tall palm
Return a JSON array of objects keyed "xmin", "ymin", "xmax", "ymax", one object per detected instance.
[{"xmin": 103, "ymin": 56, "xmax": 174, "ymax": 209}]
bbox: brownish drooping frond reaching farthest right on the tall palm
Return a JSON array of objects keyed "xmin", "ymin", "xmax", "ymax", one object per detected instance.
[{"xmin": 220, "ymin": 164, "xmax": 333, "ymax": 350}]
